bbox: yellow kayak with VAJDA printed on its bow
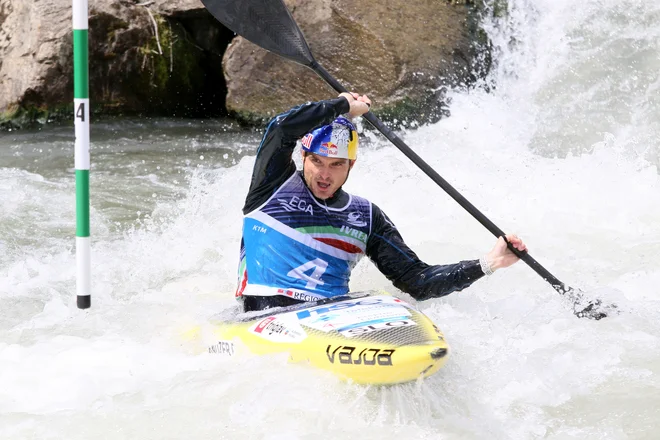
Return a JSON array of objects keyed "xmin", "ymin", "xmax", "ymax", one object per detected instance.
[{"xmin": 196, "ymin": 292, "xmax": 449, "ymax": 385}]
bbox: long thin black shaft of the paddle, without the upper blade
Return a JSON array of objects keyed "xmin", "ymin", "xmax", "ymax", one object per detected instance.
[{"xmin": 309, "ymin": 61, "xmax": 566, "ymax": 294}]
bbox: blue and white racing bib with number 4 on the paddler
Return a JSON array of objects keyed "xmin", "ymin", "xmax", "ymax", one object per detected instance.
[{"xmin": 236, "ymin": 173, "xmax": 371, "ymax": 301}]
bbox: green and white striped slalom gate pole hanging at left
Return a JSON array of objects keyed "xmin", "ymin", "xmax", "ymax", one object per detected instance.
[{"xmin": 73, "ymin": 0, "xmax": 92, "ymax": 309}]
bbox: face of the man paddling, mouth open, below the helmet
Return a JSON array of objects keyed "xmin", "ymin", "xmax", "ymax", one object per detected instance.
[{"xmin": 303, "ymin": 152, "xmax": 354, "ymax": 200}]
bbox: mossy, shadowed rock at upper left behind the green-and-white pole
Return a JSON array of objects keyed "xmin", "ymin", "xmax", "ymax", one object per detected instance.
[{"xmin": 0, "ymin": 0, "xmax": 233, "ymax": 126}]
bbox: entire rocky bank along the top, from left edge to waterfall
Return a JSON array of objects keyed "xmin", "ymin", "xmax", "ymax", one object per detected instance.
[{"xmin": 0, "ymin": 0, "xmax": 490, "ymax": 128}]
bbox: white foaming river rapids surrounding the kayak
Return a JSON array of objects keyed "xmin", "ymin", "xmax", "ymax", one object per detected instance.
[{"xmin": 0, "ymin": 0, "xmax": 660, "ymax": 439}]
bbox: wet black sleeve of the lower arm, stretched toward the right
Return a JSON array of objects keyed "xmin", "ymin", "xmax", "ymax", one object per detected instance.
[{"xmin": 367, "ymin": 204, "xmax": 484, "ymax": 301}]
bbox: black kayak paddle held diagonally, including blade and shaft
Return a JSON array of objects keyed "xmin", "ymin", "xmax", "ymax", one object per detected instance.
[{"xmin": 202, "ymin": 0, "xmax": 607, "ymax": 320}]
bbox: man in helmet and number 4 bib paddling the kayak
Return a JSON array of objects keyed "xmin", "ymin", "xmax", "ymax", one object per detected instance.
[{"xmin": 236, "ymin": 93, "xmax": 526, "ymax": 311}]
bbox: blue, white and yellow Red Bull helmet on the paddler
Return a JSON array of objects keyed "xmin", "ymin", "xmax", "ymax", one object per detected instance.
[{"xmin": 300, "ymin": 116, "xmax": 358, "ymax": 160}]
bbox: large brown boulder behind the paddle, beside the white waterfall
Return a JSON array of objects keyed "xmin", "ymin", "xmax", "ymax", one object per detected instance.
[{"xmin": 223, "ymin": 0, "xmax": 487, "ymax": 122}]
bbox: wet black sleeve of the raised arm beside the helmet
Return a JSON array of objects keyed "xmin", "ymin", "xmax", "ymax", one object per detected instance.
[{"xmin": 243, "ymin": 98, "xmax": 350, "ymax": 214}]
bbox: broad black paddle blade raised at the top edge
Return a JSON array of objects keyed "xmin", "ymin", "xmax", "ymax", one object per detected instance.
[{"xmin": 202, "ymin": 0, "xmax": 314, "ymax": 66}]
